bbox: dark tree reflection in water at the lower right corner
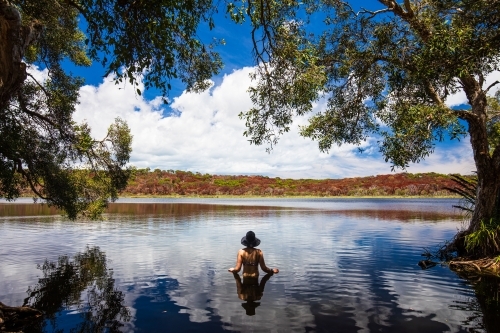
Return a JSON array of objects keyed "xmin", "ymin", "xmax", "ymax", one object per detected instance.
[{"xmin": 451, "ymin": 274, "xmax": 500, "ymax": 333}]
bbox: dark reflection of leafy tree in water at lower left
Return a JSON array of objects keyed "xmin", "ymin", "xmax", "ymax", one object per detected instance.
[{"xmin": 13, "ymin": 247, "xmax": 130, "ymax": 333}]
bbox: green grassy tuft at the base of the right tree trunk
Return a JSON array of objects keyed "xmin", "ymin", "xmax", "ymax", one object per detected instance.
[{"xmin": 465, "ymin": 218, "xmax": 500, "ymax": 256}]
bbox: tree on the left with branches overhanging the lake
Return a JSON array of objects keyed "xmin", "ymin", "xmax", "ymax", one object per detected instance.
[{"xmin": 0, "ymin": 0, "xmax": 222, "ymax": 218}]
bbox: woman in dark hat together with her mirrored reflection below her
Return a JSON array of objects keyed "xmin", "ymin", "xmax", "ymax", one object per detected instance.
[{"xmin": 228, "ymin": 231, "xmax": 279, "ymax": 316}]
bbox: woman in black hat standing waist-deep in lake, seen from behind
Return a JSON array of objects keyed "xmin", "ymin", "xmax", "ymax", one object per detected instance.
[{"xmin": 228, "ymin": 231, "xmax": 279, "ymax": 278}]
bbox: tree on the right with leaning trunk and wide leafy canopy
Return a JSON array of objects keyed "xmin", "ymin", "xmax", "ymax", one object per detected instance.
[{"xmin": 236, "ymin": 0, "xmax": 500, "ymax": 244}]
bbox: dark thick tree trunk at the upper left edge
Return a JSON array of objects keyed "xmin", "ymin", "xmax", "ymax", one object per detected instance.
[{"xmin": 0, "ymin": 0, "xmax": 42, "ymax": 110}]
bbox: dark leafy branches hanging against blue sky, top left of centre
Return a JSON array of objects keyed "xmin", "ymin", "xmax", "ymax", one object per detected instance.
[{"xmin": 74, "ymin": 0, "xmax": 222, "ymax": 94}]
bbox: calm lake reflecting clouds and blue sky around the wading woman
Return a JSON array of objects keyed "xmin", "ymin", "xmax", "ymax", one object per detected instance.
[{"xmin": 0, "ymin": 199, "xmax": 500, "ymax": 333}]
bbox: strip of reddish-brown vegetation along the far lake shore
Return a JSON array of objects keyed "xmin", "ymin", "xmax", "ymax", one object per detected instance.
[{"xmin": 115, "ymin": 169, "xmax": 466, "ymax": 197}]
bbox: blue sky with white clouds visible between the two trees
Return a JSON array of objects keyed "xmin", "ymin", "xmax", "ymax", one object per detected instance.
[{"xmin": 36, "ymin": 1, "xmax": 488, "ymax": 178}]
